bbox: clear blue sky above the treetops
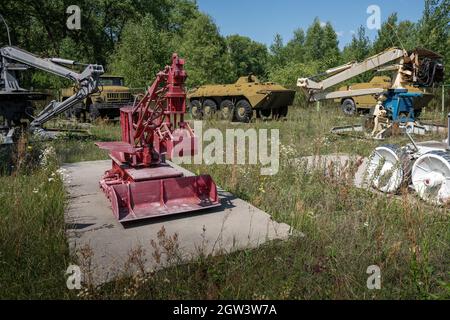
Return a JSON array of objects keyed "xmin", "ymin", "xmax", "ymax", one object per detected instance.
[{"xmin": 197, "ymin": 0, "xmax": 424, "ymax": 48}]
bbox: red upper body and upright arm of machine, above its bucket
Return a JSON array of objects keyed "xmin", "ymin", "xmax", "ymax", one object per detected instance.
[{"xmin": 107, "ymin": 54, "xmax": 196, "ymax": 166}]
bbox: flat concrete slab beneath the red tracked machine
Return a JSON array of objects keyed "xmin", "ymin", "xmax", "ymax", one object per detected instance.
[{"xmin": 63, "ymin": 160, "xmax": 291, "ymax": 284}]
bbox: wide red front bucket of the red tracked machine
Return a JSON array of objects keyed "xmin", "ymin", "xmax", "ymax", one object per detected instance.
[{"xmin": 108, "ymin": 175, "xmax": 220, "ymax": 222}]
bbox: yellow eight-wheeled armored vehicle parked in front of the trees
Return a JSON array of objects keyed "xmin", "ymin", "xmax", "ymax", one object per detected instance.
[{"xmin": 188, "ymin": 75, "xmax": 295, "ymax": 122}]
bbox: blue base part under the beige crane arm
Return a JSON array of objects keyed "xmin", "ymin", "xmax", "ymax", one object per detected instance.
[{"xmin": 383, "ymin": 89, "xmax": 423, "ymax": 123}]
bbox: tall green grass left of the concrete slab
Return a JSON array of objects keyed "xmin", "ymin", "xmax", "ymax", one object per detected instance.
[{"xmin": 0, "ymin": 144, "xmax": 70, "ymax": 299}]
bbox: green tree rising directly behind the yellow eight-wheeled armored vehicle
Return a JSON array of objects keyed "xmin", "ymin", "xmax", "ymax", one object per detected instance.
[{"xmin": 226, "ymin": 35, "xmax": 268, "ymax": 78}]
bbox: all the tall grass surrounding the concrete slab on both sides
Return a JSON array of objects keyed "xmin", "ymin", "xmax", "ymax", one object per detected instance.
[{"xmin": 0, "ymin": 108, "xmax": 450, "ymax": 299}]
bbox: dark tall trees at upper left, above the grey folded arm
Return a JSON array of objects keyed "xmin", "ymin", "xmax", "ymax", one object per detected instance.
[{"xmin": 0, "ymin": 0, "xmax": 198, "ymax": 87}]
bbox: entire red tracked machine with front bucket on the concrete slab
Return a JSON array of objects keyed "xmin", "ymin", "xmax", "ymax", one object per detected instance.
[{"xmin": 97, "ymin": 53, "xmax": 220, "ymax": 222}]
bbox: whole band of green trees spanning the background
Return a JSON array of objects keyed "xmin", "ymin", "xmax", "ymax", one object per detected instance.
[{"xmin": 0, "ymin": 0, "xmax": 450, "ymax": 87}]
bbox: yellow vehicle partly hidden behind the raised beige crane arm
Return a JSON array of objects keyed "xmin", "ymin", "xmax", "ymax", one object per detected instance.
[{"xmin": 334, "ymin": 76, "xmax": 432, "ymax": 115}]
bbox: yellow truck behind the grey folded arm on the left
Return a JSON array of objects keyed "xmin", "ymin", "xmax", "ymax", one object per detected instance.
[{"xmin": 60, "ymin": 75, "xmax": 134, "ymax": 121}]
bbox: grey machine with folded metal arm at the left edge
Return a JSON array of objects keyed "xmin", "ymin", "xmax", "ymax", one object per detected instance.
[{"xmin": 0, "ymin": 46, "xmax": 104, "ymax": 144}]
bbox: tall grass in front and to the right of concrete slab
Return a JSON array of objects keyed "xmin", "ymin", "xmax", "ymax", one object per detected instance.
[{"xmin": 61, "ymin": 109, "xmax": 450, "ymax": 299}]
